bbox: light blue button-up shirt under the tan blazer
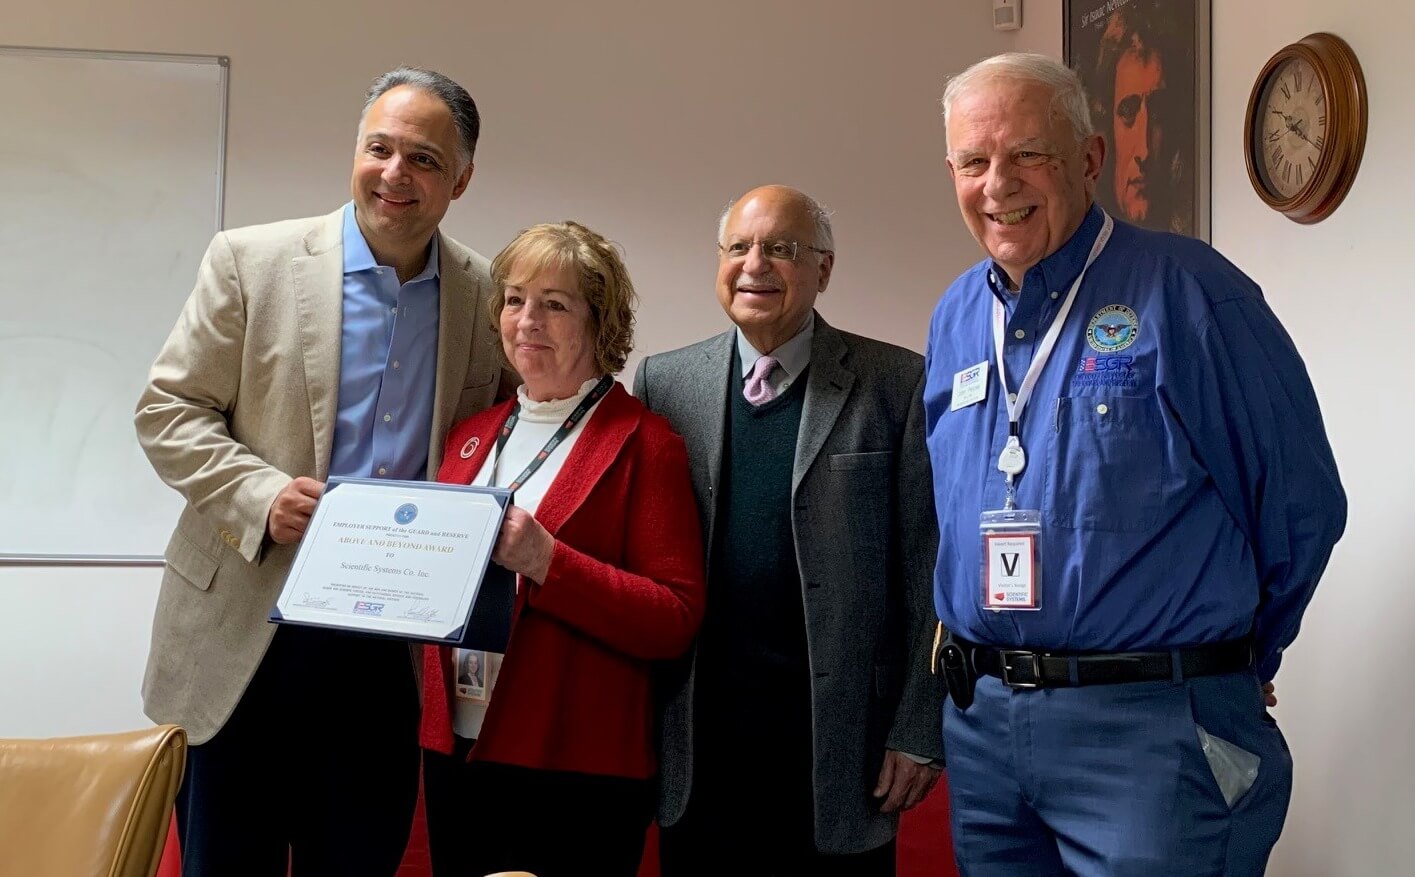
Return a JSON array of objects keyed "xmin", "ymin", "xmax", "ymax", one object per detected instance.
[{"xmin": 330, "ymin": 202, "xmax": 439, "ymax": 480}]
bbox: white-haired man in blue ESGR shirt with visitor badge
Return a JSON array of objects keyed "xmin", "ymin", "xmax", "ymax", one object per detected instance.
[{"xmin": 924, "ymin": 55, "xmax": 1346, "ymax": 877}]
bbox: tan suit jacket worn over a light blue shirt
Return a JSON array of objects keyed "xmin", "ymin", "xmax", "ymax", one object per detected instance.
[{"xmin": 136, "ymin": 208, "xmax": 515, "ymax": 744}]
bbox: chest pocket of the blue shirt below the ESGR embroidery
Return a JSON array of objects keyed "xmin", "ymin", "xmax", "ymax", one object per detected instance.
[{"xmin": 1044, "ymin": 396, "xmax": 1165, "ymax": 532}]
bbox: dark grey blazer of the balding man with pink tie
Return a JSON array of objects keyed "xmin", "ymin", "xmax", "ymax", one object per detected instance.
[{"xmin": 634, "ymin": 314, "xmax": 942, "ymax": 853}]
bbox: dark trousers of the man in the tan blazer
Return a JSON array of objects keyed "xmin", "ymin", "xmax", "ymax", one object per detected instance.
[{"xmin": 177, "ymin": 627, "xmax": 420, "ymax": 877}]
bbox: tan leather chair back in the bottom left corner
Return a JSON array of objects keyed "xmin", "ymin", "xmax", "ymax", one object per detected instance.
[{"xmin": 0, "ymin": 724, "xmax": 187, "ymax": 877}]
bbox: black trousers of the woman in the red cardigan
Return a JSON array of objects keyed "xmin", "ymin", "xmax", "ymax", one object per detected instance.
[{"xmin": 423, "ymin": 740, "xmax": 655, "ymax": 877}]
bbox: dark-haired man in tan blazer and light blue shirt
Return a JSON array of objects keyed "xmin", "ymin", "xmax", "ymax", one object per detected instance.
[{"xmin": 136, "ymin": 68, "xmax": 515, "ymax": 877}]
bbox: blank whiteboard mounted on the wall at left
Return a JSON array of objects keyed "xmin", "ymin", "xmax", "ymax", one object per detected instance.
[{"xmin": 0, "ymin": 47, "xmax": 228, "ymax": 563}]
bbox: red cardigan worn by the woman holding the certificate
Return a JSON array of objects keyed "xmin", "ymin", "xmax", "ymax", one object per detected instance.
[{"xmin": 422, "ymin": 383, "xmax": 705, "ymax": 778}]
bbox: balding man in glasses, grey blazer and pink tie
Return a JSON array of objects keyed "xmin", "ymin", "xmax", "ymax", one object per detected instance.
[{"xmin": 634, "ymin": 185, "xmax": 942, "ymax": 877}]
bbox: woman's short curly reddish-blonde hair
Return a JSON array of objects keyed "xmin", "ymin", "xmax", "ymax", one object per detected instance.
[{"xmin": 488, "ymin": 219, "xmax": 638, "ymax": 375}]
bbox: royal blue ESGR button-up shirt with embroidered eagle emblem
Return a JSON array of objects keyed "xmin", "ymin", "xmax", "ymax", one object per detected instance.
[{"xmin": 924, "ymin": 207, "xmax": 1346, "ymax": 679}]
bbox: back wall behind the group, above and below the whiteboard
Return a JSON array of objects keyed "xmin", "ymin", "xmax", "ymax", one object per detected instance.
[{"xmin": 0, "ymin": 0, "xmax": 1007, "ymax": 736}]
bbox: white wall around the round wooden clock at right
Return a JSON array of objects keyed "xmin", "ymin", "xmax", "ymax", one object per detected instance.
[{"xmin": 1015, "ymin": 0, "xmax": 1415, "ymax": 877}]
